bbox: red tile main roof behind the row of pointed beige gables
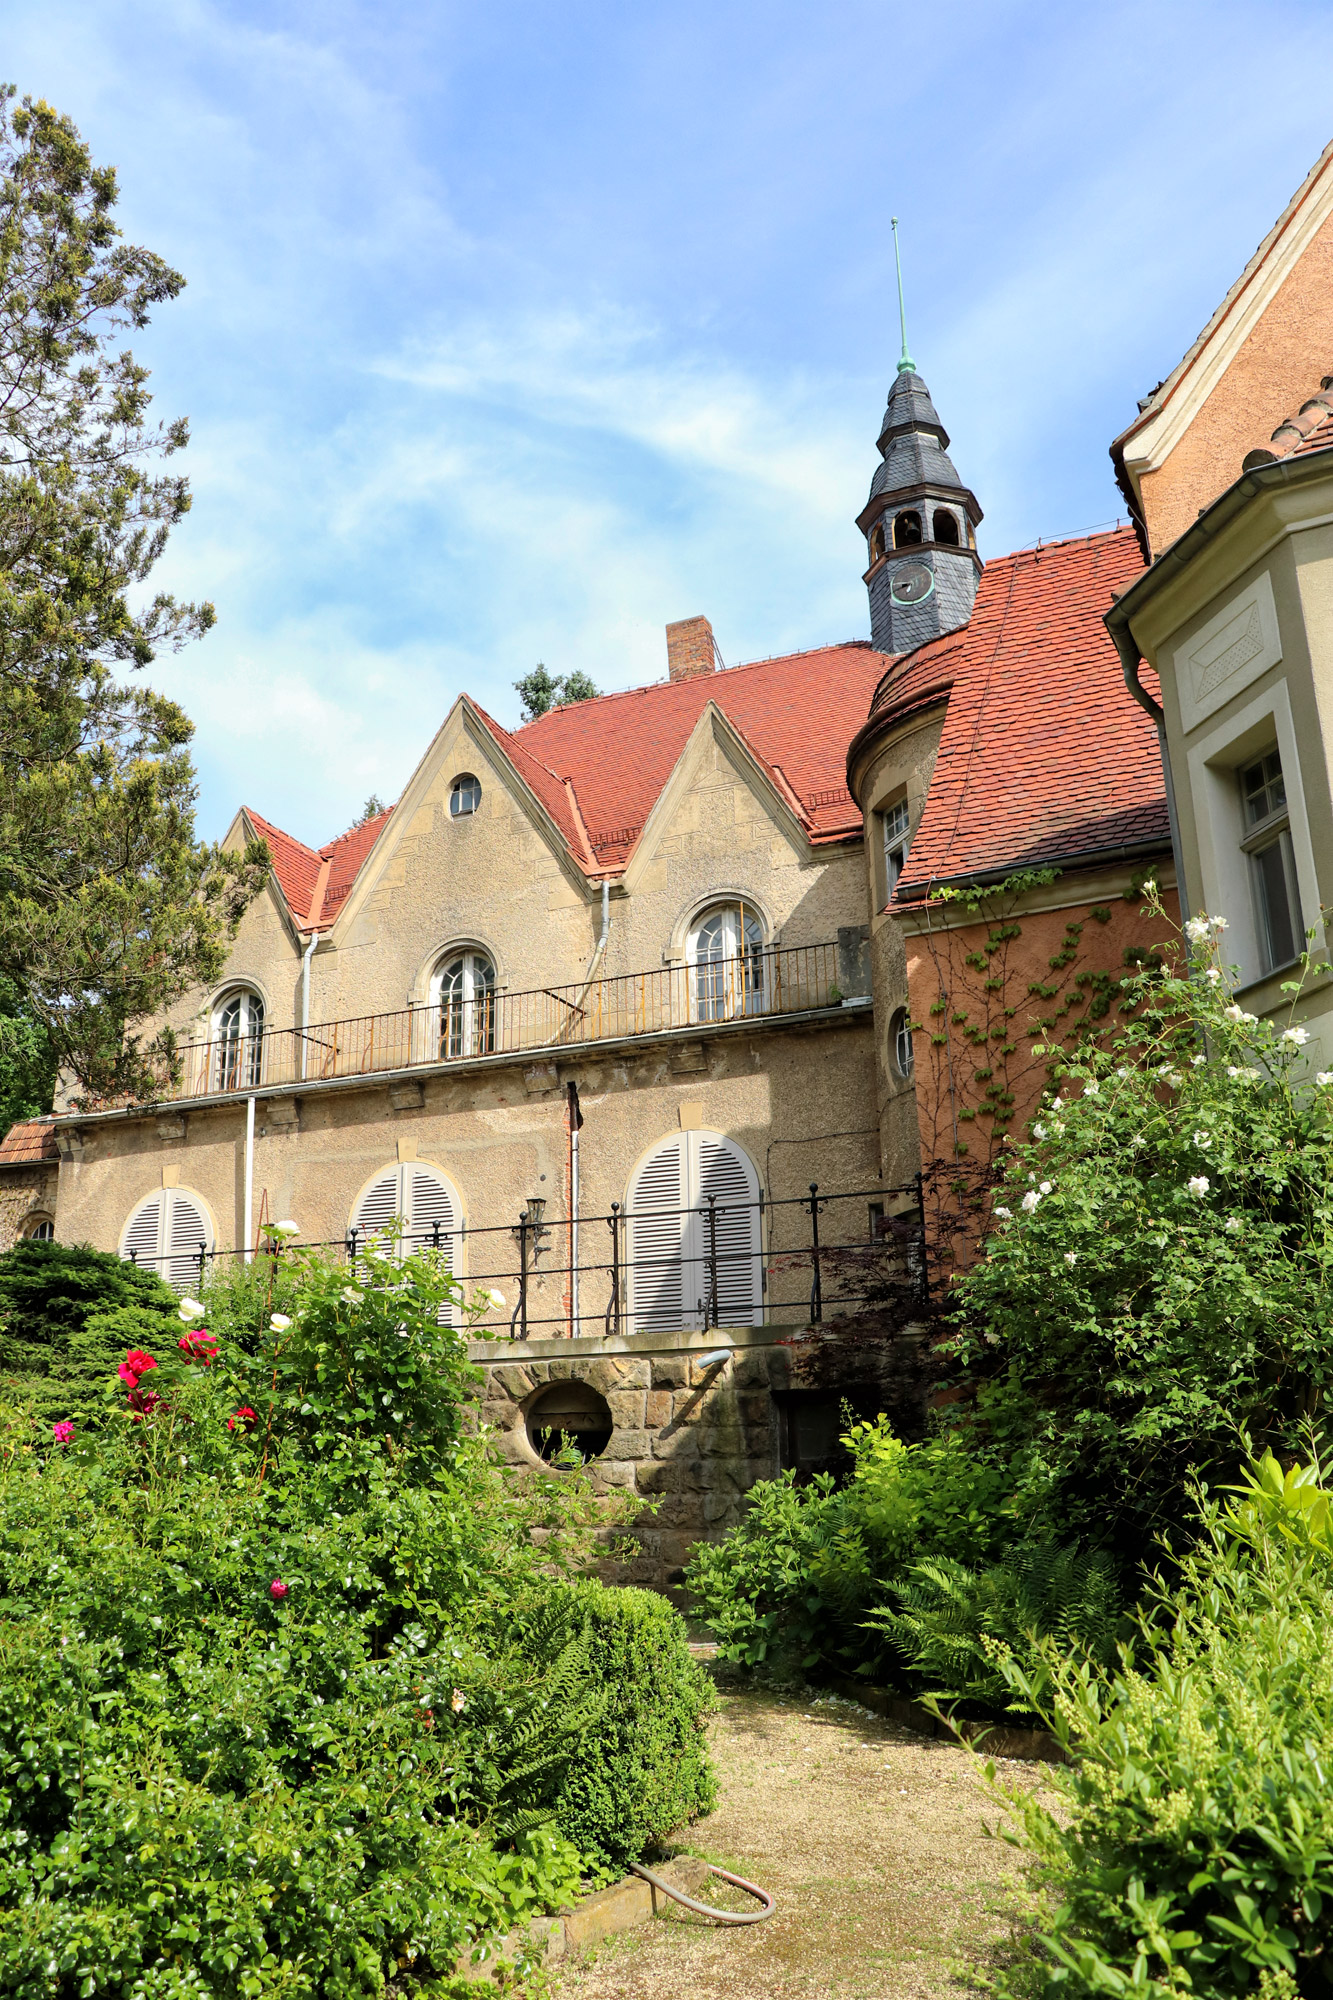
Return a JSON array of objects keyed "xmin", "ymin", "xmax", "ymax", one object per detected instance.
[{"xmin": 246, "ymin": 640, "xmax": 885, "ymax": 930}]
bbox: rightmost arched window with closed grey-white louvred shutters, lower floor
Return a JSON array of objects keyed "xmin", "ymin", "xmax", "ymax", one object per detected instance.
[{"xmin": 624, "ymin": 1132, "xmax": 765, "ymax": 1334}]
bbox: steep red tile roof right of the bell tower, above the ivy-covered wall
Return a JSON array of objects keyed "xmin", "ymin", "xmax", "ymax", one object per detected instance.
[{"xmin": 856, "ymin": 528, "xmax": 1171, "ymax": 900}]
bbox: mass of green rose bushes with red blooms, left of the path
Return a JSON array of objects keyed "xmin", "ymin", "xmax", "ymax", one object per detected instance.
[{"xmin": 0, "ymin": 1254, "xmax": 707, "ymax": 2000}]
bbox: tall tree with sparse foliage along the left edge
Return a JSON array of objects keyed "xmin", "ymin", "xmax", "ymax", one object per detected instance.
[{"xmin": 0, "ymin": 86, "xmax": 266, "ymax": 1098}]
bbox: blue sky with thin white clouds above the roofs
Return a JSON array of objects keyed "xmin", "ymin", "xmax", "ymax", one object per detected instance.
[{"xmin": 4, "ymin": 0, "xmax": 1329, "ymax": 842}]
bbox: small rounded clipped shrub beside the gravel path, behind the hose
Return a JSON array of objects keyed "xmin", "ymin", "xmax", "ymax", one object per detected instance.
[{"xmin": 528, "ymin": 1582, "xmax": 717, "ymax": 1868}]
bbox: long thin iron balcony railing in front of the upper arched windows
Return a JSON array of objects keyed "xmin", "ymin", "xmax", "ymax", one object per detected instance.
[{"xmin": 150, "ymin": 944, "xmax": 843, "ymax": 1100}]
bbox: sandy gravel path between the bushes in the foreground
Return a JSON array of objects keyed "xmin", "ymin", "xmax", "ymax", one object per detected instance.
[{"xmin": 552, "ymin": 1694, "xmax": 1037, "ymax": 2000}]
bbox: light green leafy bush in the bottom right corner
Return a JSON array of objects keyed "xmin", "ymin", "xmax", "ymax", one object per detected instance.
[{"xmin": 984, "ymin": 1456, "xmax": 1333, "ymax": 2000}]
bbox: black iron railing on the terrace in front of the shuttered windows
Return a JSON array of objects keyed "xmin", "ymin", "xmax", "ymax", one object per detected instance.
[{"xmin": 130, "ymin": 1176, "xmax": 929, "ymax": 1340}]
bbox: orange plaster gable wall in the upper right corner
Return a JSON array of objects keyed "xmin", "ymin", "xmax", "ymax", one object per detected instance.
[{"xmin": 1139, "ymin": 216, "xmax": 1333, "ymax": 556}]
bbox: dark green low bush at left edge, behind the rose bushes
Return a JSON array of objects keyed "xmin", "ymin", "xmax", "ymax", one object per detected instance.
[{"xmin": 0, "ymin": 1242, "xmax": 178, "ymax": 1422}]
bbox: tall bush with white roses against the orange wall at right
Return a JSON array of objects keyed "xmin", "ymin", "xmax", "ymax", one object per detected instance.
[{"xmin": 957, "ymin": 918, "xmax": 1333, "ymax": 1556}]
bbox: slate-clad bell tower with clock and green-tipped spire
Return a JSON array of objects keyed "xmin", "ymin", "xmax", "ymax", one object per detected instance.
[{"xmin": 857, "ymin": 216, "xmax": 981, "ymax": 652}]
